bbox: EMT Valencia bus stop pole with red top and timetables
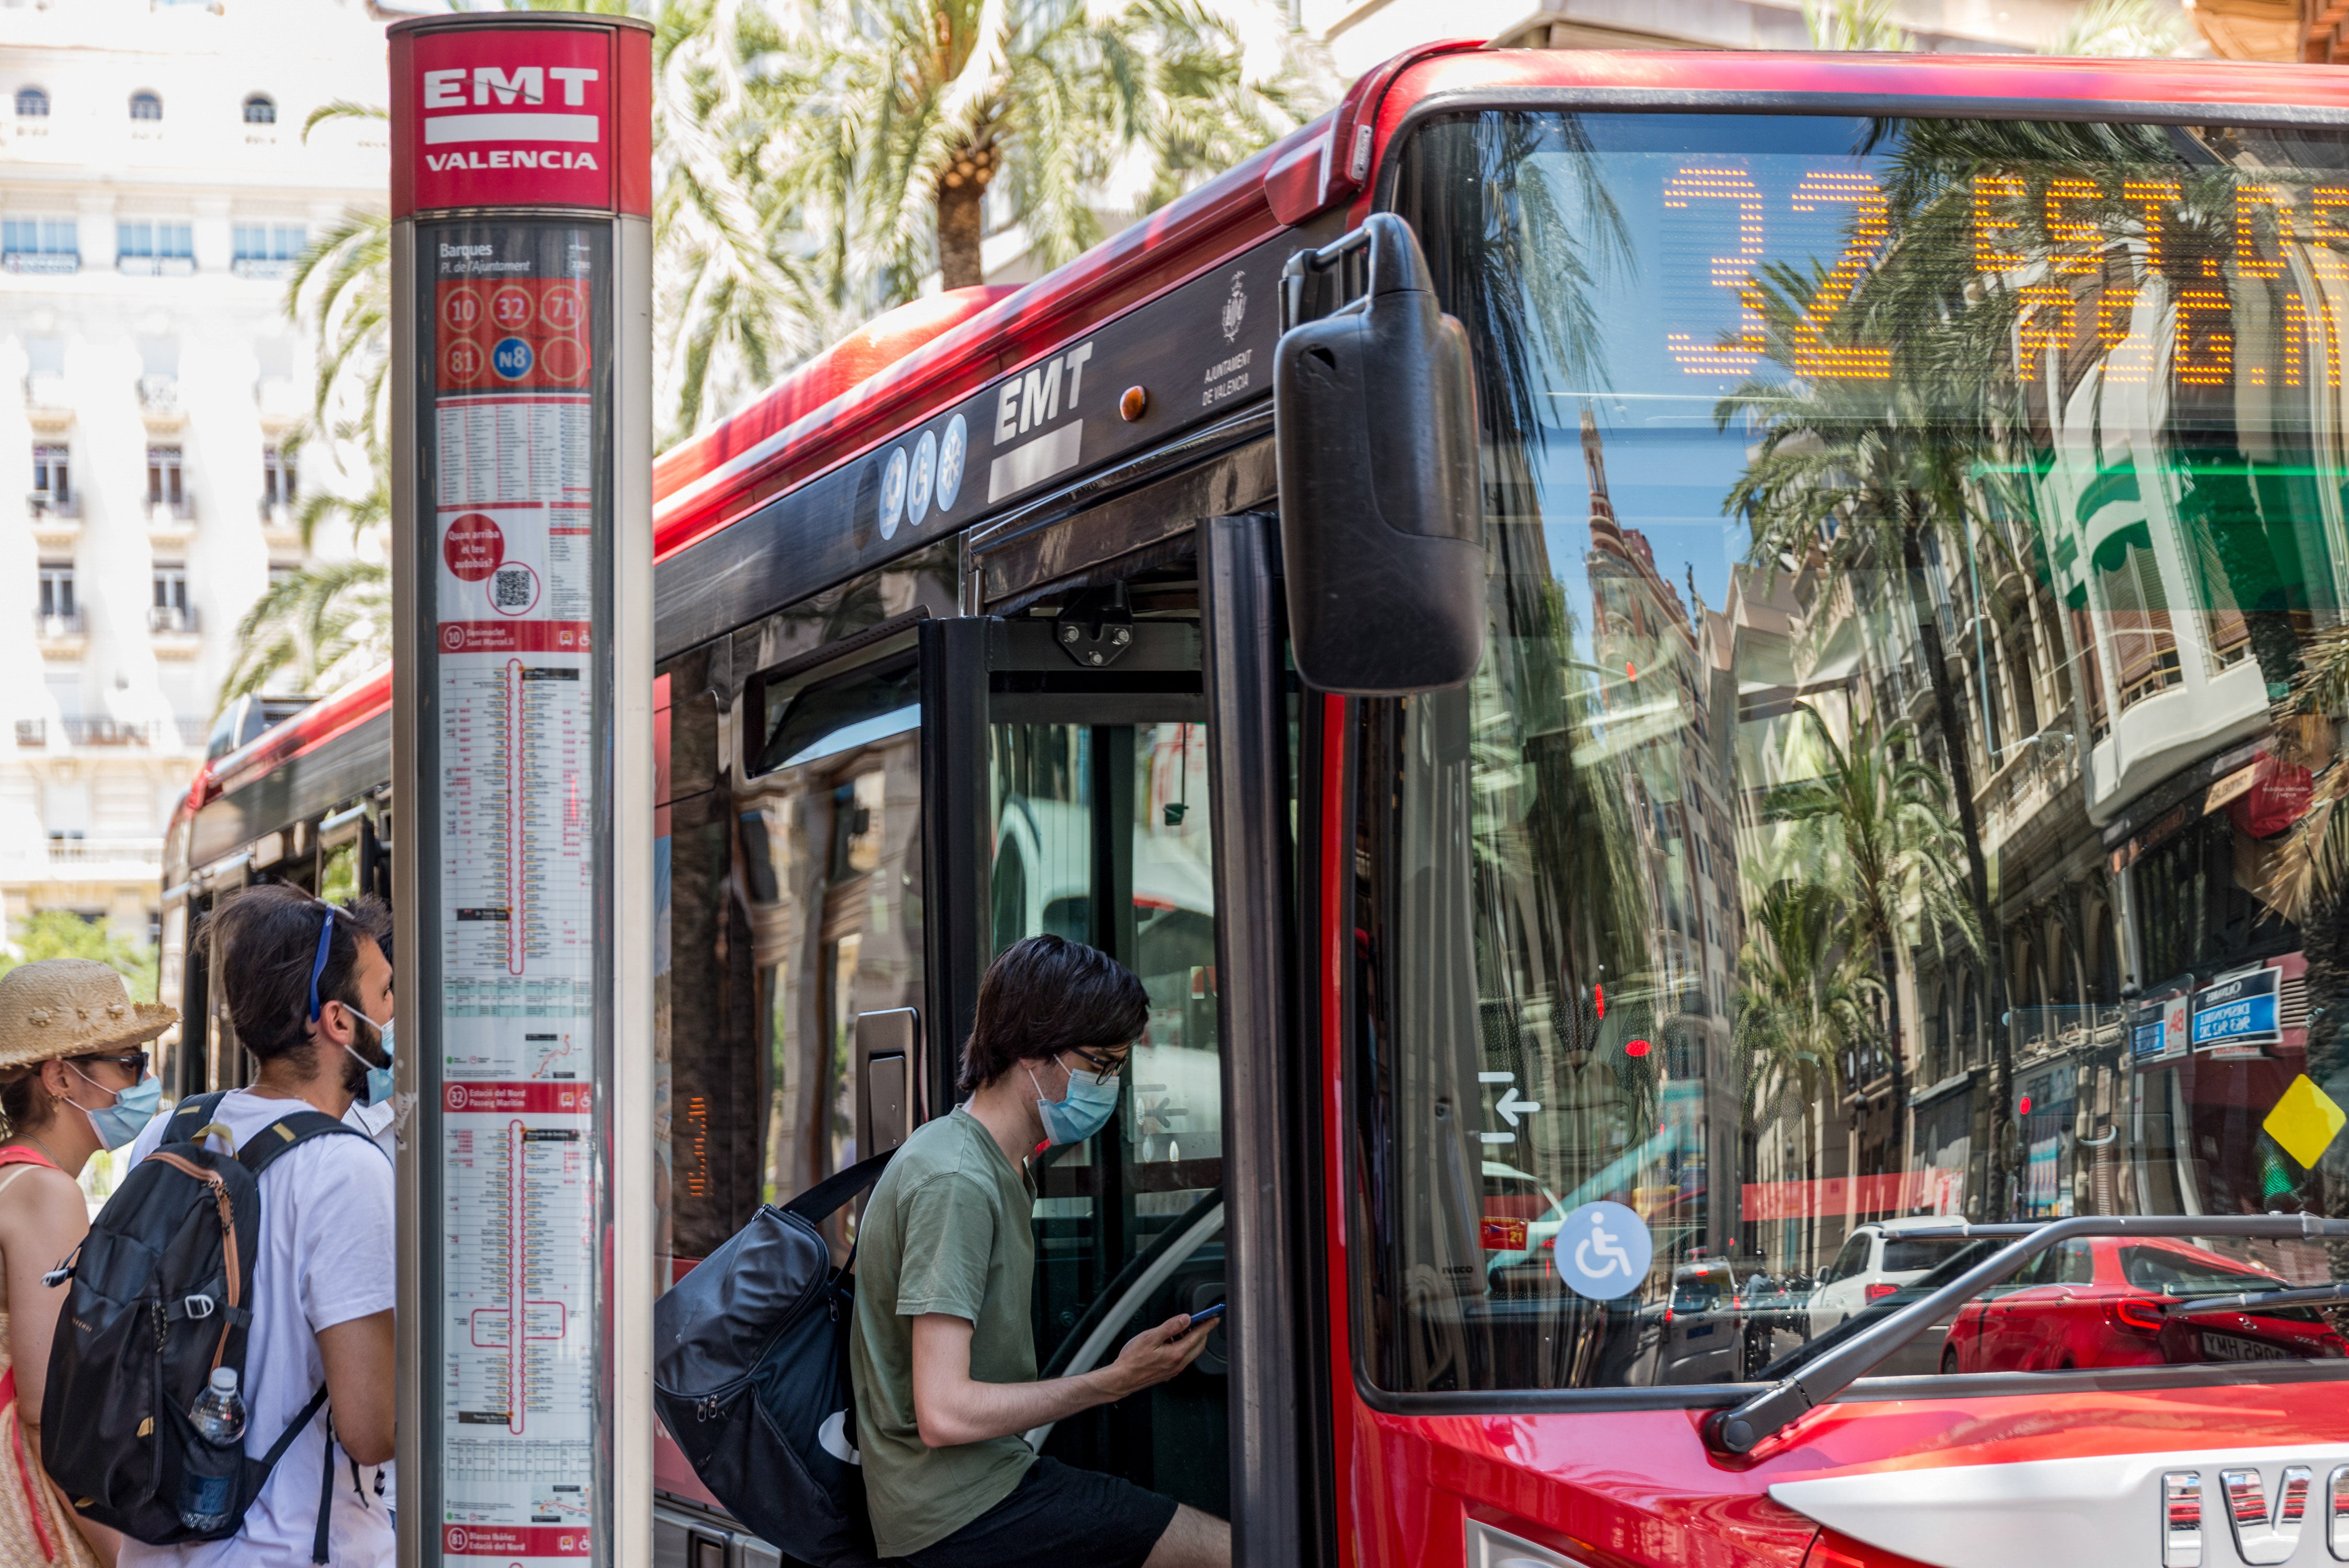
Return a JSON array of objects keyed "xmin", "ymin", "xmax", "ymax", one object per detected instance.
[{"xmin": 390, "ymin": 11, "xmax": 655, "ymax": 1568}]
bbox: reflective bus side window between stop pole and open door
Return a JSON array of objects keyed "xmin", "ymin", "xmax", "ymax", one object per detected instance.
[{"xmin": 655, "ymin": 545, "xmax": 954, "ymax": 1261}]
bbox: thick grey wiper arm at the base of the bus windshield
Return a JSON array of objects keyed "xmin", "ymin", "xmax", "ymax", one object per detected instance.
[{"xmin": 1703, "ymin": 1214, "xmax": 2349, "ymax": 1458}]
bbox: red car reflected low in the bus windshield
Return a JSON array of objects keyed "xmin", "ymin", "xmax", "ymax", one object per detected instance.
[{"xmin": 1940, "ymin": 1237, "xmax": 2349, "ymax": 1373}]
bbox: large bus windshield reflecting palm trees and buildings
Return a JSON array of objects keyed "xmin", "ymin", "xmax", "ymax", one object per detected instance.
[{"xmin": 1346, "ymin": 110, "xmax": 2349, "ymax": 1392}]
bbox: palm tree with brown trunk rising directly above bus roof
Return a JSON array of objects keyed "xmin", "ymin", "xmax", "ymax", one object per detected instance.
[{"xmin": 747, "ymin": 0, "xmax": 1325, "ymax": 305}]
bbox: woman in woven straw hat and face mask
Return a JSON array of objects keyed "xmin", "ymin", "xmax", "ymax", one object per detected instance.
[{"xmin": 0, "ymin": 958, "xmax": 179, "ymax": 1568}]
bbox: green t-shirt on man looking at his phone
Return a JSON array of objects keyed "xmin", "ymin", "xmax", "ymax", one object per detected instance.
[{"xmin": 850, "ymin": 1105, "xmax": 1036, "ymax": 1557}]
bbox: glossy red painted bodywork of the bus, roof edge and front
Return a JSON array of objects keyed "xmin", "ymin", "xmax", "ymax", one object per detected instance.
[{"xmin": 174, "ymin": 42, "xmax": 2349, "ymax": 1568}]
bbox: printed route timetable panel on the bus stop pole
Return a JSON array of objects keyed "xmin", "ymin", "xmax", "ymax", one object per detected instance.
[{"xmin": 418, "ymin": 221, "xmax": 611, "ymax": 1568}]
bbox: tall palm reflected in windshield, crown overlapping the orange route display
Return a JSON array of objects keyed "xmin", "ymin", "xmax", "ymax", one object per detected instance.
[{"xmin": 1715, "ymin": 120, "xmax": 2295, "ymax": 1214}]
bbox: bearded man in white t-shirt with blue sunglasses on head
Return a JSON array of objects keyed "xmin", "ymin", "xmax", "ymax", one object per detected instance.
[{"xmin": 120, "ymin": 885, "xmax": 397, "ymax": 1568}]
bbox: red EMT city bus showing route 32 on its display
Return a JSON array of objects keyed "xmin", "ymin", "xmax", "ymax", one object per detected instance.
[{"xmin": 165, "ymin": 47, "xmax": 2349, "ymax": 1568}]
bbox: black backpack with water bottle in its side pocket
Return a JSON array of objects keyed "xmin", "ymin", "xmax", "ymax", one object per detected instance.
[{"xmin": 40, "ymin": 1091, "xmax": 366, "ymax": 1563}]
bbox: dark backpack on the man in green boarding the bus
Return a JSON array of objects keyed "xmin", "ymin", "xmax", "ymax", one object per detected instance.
[{"xmin": 653, "ymin": 1155, "xmax": 890, "ymax": 1568}]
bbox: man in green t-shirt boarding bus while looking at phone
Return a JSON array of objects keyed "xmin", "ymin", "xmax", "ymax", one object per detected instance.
[{"xmin": 850, "ymin": 937, "xmax": 1231, "ymax": 1568}]
